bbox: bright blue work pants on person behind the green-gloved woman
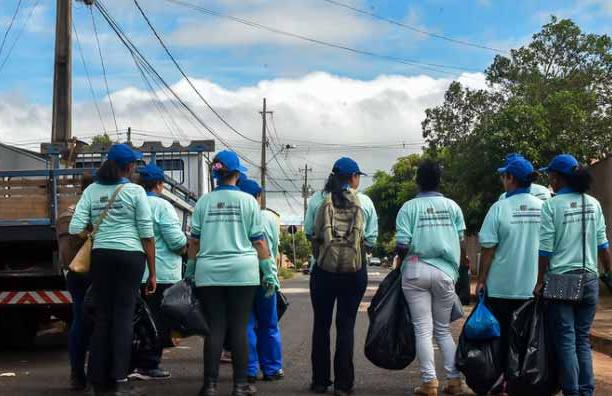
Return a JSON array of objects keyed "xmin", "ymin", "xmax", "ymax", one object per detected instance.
[{"xmin": 248, "ymin": 287, "xmax": 283, "ymax": 377}]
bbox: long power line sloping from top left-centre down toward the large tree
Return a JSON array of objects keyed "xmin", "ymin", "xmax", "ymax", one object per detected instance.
[{"xmin": 166, "ymin": 0, "xmax": 478, "ymax": 73}]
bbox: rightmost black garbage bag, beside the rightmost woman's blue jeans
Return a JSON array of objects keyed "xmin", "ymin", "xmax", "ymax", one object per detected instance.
[{"xmin": 506, "ymin": 299, "xmax": 558, "ymax": 396}]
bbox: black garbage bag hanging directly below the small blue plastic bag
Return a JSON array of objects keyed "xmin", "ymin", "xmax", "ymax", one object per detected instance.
[{"xmin": 455, "ymin": 300, "xmax": 504, "ymax": 395}]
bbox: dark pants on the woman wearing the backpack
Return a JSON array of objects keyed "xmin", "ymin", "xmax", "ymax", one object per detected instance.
[{"xmin": 310, "ymin": 266, "xmax": 368, "ymax": 391}]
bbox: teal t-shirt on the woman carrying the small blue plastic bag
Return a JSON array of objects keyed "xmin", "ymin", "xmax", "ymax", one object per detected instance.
[{"xmin": 479, "ymin": 193, "xmax": 543, "ymax": 299}]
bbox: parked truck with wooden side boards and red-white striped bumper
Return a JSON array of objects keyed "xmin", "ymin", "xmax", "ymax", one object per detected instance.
[{"xmin": 0, "ymin": 140, "xmax": 214, "ymax": 346}]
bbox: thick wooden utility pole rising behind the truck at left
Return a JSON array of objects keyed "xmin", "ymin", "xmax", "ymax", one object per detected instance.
[{"xmin": 51, "ymin": 0, "xmax": 72, "ymax": 144}]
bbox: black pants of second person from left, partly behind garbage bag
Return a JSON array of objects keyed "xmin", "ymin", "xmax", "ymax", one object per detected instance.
[{"xmin": 133, "ymin": 283, "xmax": 172, "ymax": 370}]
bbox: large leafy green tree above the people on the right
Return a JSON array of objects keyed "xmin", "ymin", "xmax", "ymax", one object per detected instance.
[{"xmin": 422, "ymin": 17, "xmax": 612, "ymax": 232}]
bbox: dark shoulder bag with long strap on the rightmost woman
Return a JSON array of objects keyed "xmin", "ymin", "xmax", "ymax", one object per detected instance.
[{"xmin": 544, "ymin": 194, "xmax": 586, "ymax": 302}]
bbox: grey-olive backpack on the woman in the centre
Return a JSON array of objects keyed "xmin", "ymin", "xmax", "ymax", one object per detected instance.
[{"xmin": 313, "ymin": 191, "xmax": 364, "ymax": 273}]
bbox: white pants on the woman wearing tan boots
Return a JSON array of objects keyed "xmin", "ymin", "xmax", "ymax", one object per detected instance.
[{"xmin": 402, "ymin": 257, "xmax": 461, "ymax": 382}]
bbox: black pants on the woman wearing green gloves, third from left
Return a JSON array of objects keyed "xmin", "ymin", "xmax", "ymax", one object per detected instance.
[{"xmin": 196, "ymin": 286, "xmax": 259, "ymax": 384}]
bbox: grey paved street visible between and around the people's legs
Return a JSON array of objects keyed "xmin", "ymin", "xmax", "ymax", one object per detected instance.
[{"xmin": 0, "ymin": 269, "xmax": 612, "ymax": 396}]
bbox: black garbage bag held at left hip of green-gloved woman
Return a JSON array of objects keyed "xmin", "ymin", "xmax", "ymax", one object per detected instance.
[{"xmin": 161, "ymin": 279, "xmax": 209, "ymax": 336}]
